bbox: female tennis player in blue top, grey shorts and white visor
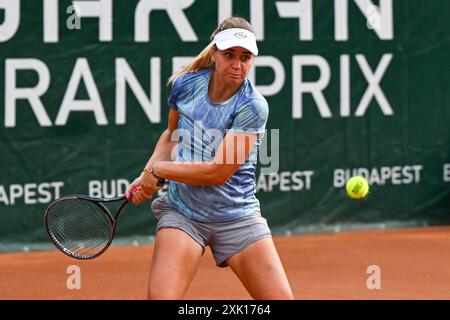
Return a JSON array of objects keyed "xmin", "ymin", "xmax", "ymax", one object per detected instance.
[{"xmin": 127, "ymin": 17, "xmax": 293, "ymax": 299}]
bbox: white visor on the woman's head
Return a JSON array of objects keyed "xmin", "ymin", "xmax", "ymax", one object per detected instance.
[{"xmin": 213, "ymin": 28, "xmax": 258, "ymax": 56}]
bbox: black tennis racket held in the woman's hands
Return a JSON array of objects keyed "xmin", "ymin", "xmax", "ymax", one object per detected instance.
[{"xmin": 44, "ymin": 187, "xmax": 148, "ymax": 259}]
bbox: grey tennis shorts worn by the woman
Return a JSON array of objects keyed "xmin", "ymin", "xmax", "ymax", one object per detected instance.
[{"xmin": 152, "ymin": 196, "xmax": 272, "ymax": 268}]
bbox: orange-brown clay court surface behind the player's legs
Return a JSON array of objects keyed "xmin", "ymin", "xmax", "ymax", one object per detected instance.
[{"xmin": 0, "ymin": 227, "xmax": 450, "ymax": 299}]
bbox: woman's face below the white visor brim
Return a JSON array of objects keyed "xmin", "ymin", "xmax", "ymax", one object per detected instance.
[{"xmin": 212, "ymin": 47, "xmax": 253, "ymax": 85}]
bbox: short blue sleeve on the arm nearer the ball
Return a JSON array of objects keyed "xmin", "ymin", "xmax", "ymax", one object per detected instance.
[{"xmin": 231, "ymin": 99, "xmax": 269, "ymax": 133}]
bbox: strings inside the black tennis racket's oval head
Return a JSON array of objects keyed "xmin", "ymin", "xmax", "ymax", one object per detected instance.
[{"xmin": 47, "ymin": 199, "xmax": 111, "ymax": 258}]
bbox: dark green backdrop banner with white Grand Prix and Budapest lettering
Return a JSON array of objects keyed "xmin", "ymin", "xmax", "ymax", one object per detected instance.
[{"xmin": 0, "ymin": 0, "xmax": 450, "ymax": 249}]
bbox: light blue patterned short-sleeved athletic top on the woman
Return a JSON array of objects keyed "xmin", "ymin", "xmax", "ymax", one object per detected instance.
[{"xmin": 166, "ymin": 69, "xmax": 269, "ymax": 222}]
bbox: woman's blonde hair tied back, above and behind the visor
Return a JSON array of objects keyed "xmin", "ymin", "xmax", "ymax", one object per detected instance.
[{"xmin": 167, "ymin": 17, "xmax": 255, "ymax": 85}]
